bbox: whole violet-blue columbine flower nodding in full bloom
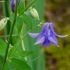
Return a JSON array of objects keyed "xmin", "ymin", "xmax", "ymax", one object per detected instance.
[{"xmin": 29, "ymin": 22, "xmax": 68, "ymax": 47}]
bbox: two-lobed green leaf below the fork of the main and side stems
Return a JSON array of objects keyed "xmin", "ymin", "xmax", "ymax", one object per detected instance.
[{"xmin": 16, "ymin": 14, "xmax": 32, "ymax": 33}]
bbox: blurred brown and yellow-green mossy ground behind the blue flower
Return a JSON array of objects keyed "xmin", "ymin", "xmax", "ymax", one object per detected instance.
[{"xmin": 0, "ymin": 0, "xmax": 70, "ymax": 70}]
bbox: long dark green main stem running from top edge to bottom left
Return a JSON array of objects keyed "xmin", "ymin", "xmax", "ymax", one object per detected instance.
[{"xmin": 2, "ymin": 0, "xmax": 18, "ymax": 70}]
